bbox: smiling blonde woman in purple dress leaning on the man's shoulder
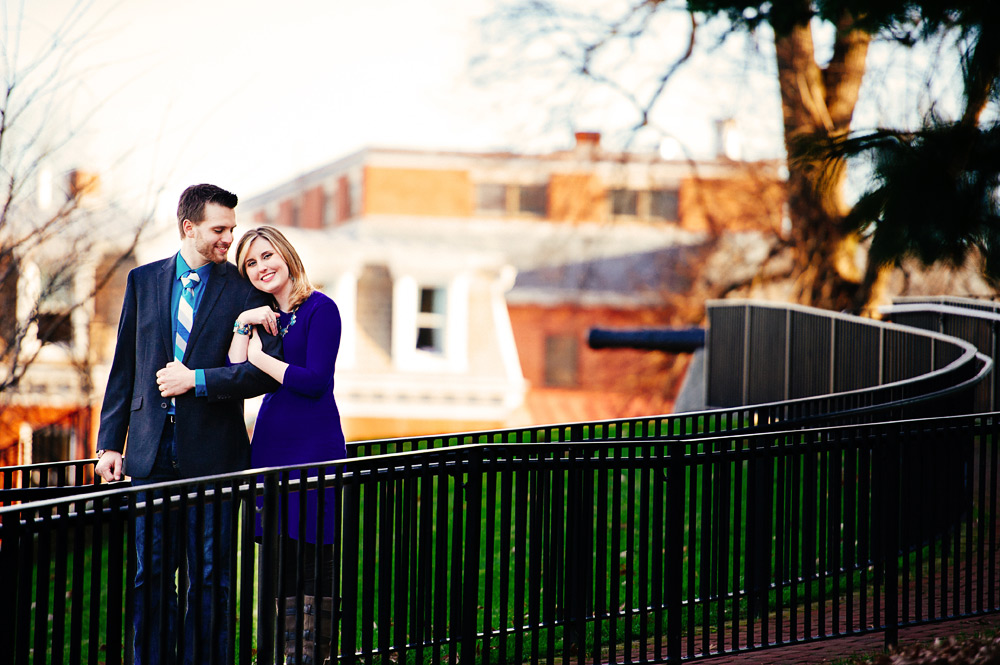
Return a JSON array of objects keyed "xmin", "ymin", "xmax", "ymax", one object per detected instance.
[{"xmin": 229, "ymin": 226, "xmax": 347, "ymax": 662}]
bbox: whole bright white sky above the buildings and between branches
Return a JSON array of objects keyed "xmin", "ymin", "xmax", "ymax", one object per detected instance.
[{"xmin": 0, "ymin": 0, "xmax": 960, "ymax": 224}]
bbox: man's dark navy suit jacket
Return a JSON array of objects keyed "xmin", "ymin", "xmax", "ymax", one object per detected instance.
[{"xmin": 97, "ymin": 255, "xmax": 282, "ymax": 478}]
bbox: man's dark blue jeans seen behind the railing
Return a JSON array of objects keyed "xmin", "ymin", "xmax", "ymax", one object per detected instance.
[{"xmin": 132, "ymin": 421, "xmax": 234, "ymax": 665}]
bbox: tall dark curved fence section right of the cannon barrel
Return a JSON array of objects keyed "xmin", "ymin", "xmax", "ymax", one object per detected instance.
[{"xmin": 706, "ymin": 300, "xmax": 977, "ymax": 413}]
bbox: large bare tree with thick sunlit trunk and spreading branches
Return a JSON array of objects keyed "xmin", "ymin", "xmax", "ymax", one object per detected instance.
[{"xmin": 474, "ymin": 0, "xmax": 971, "ymax": 311}]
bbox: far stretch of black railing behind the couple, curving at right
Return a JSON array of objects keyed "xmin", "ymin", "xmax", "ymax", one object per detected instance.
[{"xmin": 0, "ymin": 298, "xmax": 984, "ymax": 506}]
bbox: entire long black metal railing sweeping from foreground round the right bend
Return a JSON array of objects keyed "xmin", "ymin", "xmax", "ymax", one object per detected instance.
[{"xmin": 0, "ymin": 304, "xmax": 1000, "ymax": 663}]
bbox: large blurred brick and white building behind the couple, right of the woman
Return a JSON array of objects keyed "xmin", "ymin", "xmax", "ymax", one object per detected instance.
[{"xmin": 238, "ymin": 133, "xmax": 784, "ymax": 438}]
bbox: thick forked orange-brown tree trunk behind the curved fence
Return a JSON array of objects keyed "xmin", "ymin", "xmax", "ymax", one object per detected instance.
[{"xmin": 775, "ymin": 5, "xmax": 870, "ymax": 310}]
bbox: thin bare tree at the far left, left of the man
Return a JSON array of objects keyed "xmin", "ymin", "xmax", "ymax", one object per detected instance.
[{"xmin": 0, "ymin": 1, "xmax": 153, "ymax": 409}]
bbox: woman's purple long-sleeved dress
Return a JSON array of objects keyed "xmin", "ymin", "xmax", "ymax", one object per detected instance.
[{"xmin": 250, "ymin": 291, "xmax": 347, "ymax": 543}]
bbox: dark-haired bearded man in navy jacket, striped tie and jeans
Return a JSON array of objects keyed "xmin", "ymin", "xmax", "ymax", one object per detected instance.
[{"xmin": 95, "ymin": 184, "xmax": 281, "ymax": 665}]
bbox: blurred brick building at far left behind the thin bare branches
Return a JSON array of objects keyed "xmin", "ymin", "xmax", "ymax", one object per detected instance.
[{"xmin": 0, "ymin": 170, "xmax": 135, "ymax": 466}]
